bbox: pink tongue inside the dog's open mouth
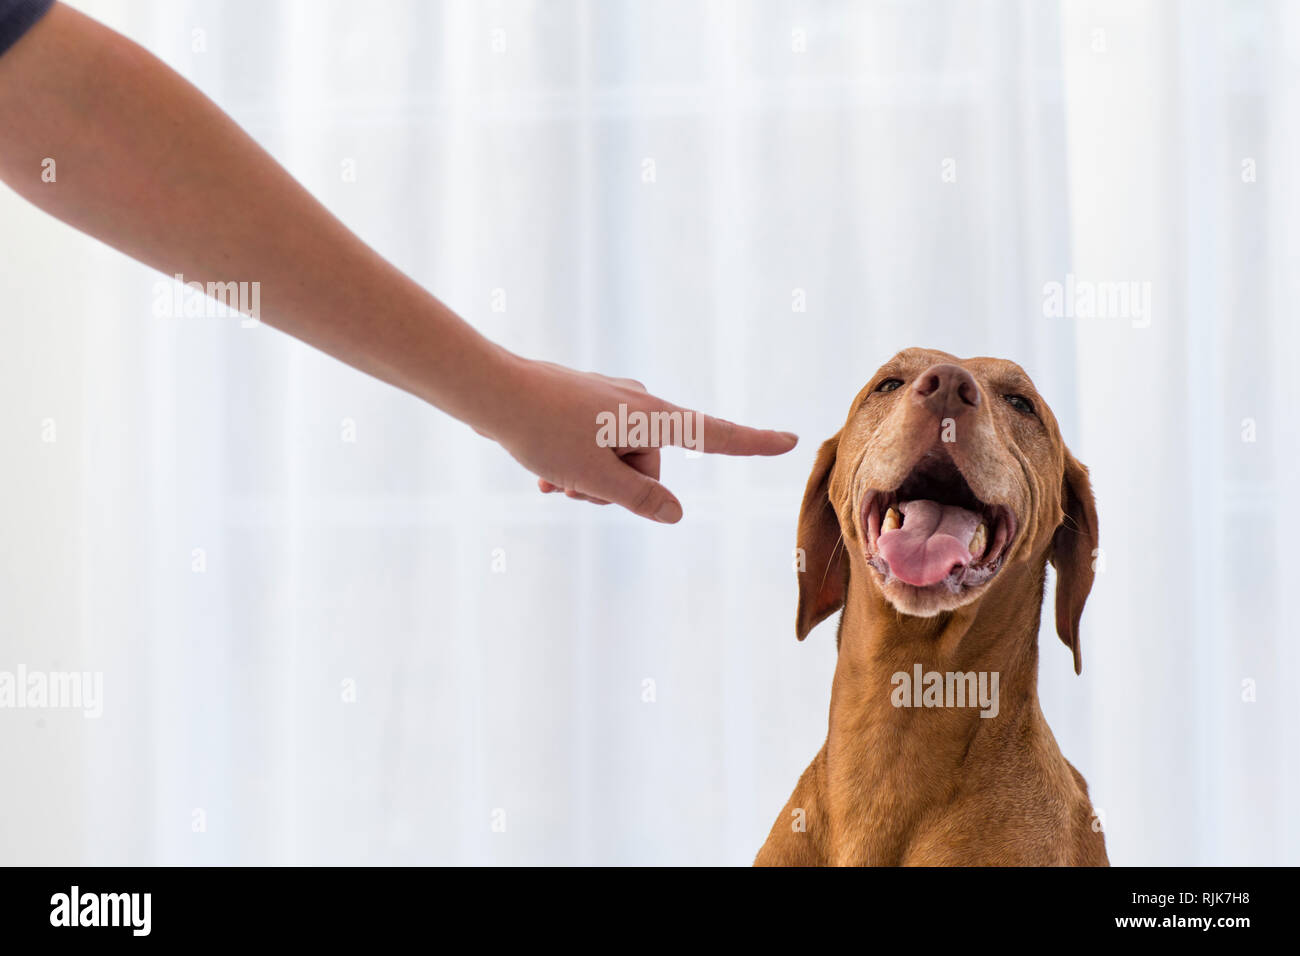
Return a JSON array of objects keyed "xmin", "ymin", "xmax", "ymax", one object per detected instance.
[{"xmin": 876, "ymin": 501, "xmax": 980, "ymax": 588}]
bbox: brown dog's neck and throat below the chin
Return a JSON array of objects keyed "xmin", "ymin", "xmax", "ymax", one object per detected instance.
[{"xmin": 827, "ymin": 563, "xmax": 1045, "ymax": 864}]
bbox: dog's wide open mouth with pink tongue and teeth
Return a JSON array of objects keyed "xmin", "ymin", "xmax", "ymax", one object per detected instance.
[{"xmin": 862, "ymin": 447, "xmax": 1015, "ymax": 593}]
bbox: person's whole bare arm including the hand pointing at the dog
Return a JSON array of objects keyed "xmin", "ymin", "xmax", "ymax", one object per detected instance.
[{"xmin": 0, "ymin": 5, "xmax": 797, "ymax": 523}]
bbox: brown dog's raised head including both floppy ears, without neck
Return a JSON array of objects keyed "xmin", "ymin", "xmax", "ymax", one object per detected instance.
[{"xmin": 796, "ymin": 349, "xmax": 1097, "ymax": 672}]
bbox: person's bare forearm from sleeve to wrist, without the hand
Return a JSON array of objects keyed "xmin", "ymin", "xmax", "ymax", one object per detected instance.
[{"xmin": 0, "ymin": 5, "xmax": 511, "ymax": 432}]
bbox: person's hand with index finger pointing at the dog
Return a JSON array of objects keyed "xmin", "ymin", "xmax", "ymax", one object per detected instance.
[{"xmin": 480, "ymin": 356, "xmax": 798, "ymax": 524}]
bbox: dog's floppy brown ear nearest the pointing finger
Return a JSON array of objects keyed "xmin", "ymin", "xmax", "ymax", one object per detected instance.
[{"xmin": 794, "ymin": 432, "xmax": 849, "ymax": 640}]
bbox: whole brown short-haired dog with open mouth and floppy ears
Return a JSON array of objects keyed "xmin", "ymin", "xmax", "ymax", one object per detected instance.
[{"xmin": 755, "ymin": 349, "xmax": 1108, "ymax": 865}]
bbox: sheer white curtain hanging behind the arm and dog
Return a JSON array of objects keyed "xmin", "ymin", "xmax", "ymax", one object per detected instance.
[{"xmin": 0, "ymin": 0, "xmax": 1300, "ymax": 864}]
